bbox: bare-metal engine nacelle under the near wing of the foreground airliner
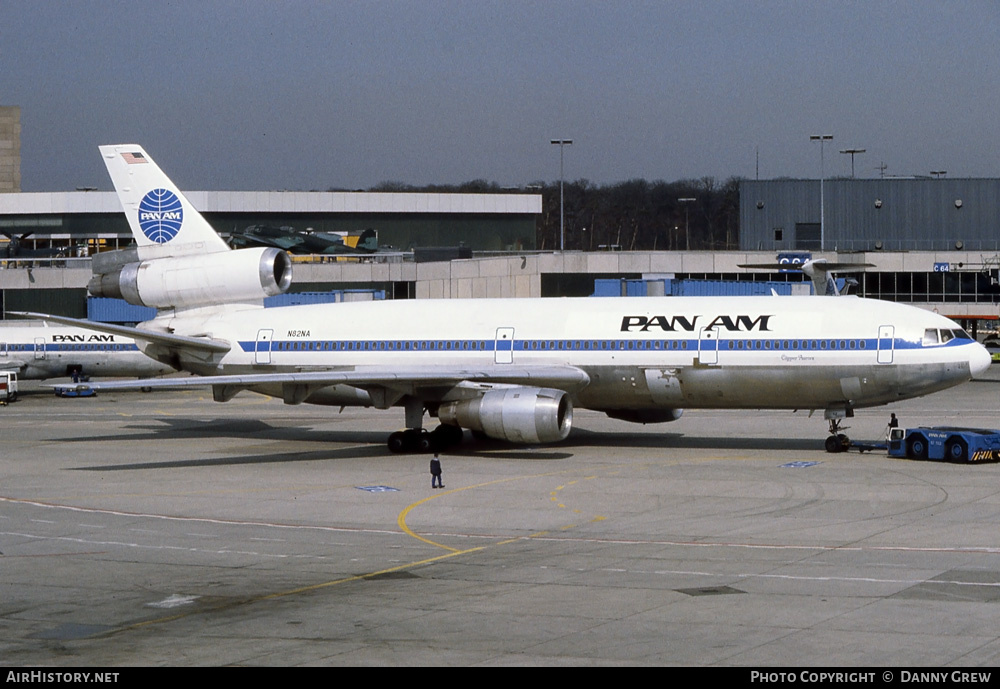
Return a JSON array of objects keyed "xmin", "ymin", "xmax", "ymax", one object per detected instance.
[{"xmin": 438, "ymin": 386, "xmax": 573, "ymax": 443}]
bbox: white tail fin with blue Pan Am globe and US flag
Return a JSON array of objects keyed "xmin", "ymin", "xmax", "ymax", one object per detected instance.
[{"xmin": 100, "ymin": 144, "xmax": 229, "ymax": 259}]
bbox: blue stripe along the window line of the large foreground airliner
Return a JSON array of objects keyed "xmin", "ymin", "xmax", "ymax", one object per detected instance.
[{"xmin": 239, "ymin": 337, "xmax": 973, "ymax": 352}]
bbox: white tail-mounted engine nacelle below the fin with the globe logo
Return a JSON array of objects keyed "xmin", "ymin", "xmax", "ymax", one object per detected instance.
[{"xmin": 87, "ymin": 247, "xmax": 292, "ymax": 308}]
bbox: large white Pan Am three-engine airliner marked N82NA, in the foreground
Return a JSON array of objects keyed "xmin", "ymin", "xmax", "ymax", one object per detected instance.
[{"xmin": 15, "ymin": 145, "xmax": 990, "ymax": 451}]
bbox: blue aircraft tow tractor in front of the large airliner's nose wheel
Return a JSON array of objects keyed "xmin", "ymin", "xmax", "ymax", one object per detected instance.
[{"xmin": 889, "ymin": 426, "xmax": 1000, "ymax": 462}]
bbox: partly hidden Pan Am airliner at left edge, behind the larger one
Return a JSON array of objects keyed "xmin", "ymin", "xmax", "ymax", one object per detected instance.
[{"xmin": 0, "ymin": 321, "xmax": 175, "ymax": 380}]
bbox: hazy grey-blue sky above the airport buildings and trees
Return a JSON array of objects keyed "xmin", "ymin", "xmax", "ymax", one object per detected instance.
[{"xmin": 0, "ymin": 0, "xmax": 1000, "ymax": 191}]
